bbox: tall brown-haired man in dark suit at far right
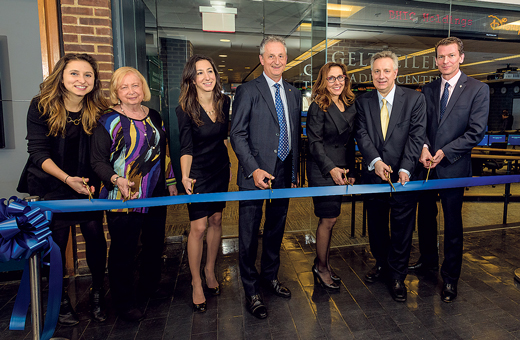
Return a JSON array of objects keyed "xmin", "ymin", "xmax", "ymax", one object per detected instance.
[{"xmin": 410, "ymin": 37, "xmax": 489, "ymax": 302}]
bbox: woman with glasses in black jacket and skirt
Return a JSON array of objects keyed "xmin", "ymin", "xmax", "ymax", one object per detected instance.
[{"xmin": 307, "ymin": 62, "xmax": 356, "ymax": 289}]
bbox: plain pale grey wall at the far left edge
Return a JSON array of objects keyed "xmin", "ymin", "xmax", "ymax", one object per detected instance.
[{"xmin": 0, "ymin": 0, "xmax": 43, "ymax": 198}]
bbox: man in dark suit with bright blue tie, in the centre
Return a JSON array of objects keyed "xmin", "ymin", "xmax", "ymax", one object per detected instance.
[{"xmin": 230, "ymin": 36, "xmax": 301, "ymax": 319}]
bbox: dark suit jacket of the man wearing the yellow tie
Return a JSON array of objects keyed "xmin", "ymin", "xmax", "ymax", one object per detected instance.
[{"xmin": 356, "ymin": 85, "xmax": 426, "ymax": 183}]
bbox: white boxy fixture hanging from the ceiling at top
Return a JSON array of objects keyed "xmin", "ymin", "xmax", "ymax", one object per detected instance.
[{"xmin": 199, "ymin": 1, "xmax": 237, "ymax": 33}]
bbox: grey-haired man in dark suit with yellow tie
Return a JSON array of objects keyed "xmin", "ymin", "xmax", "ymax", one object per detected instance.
[{"xmin": 356, "ymin": 51, "xmax": 426, "ymax": 302}]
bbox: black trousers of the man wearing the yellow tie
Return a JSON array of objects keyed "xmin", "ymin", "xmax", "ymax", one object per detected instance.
[{"xmin": 365, "ymin": 192, "xmax": 417, "ymax": 280}]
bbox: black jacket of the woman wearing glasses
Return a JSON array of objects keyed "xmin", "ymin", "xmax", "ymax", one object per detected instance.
[{"xmin": 307, "ymin": 102, "xmax": 356, "ymax": 177}]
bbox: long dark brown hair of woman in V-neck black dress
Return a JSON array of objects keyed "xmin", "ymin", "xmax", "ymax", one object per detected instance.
[{"xmin": 179, "ymin": 54, "xmax": 226, "ymax": 126}]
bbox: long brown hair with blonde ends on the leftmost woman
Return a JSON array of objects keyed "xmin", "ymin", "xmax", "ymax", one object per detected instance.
[{"xmin": 35, "ymin": 53, "xmax": 108, "ymax": 137}]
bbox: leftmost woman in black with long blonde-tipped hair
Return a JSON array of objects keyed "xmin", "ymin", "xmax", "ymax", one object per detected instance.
[{"xmin": 18, "ymin": 54, "xmax": 108, "ymax": 326}]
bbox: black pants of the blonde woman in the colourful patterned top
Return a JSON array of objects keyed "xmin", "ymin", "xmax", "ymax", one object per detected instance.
[{"xmin": 107, "ymin": 207, "xmax": 166, "ymax": 311}]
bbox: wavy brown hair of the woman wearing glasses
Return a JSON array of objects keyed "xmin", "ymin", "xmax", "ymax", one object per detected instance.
[{"xmin": 312, "ymin": 62, "xmax": 356, "ymax": 112}]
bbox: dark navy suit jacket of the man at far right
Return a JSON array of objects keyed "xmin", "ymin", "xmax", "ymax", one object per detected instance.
[{"xmin": 423, "ymin": 73, "xmax": 489, "ymax": 178}]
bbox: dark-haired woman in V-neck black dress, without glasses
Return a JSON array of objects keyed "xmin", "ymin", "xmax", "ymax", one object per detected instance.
[{"xmin": 175, "ymin": 55, "xmax": 231, "ymax": 312}]
